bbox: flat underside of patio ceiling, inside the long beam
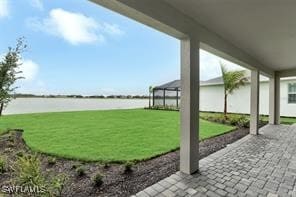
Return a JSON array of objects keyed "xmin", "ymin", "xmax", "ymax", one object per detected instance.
[{"xmin": 165, "ymin": 0, "xmax": 296, "ymax": 70}]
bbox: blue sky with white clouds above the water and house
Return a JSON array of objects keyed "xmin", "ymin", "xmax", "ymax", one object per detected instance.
[{"xmin": 0, "ymin": 0, "xmax": 243, "ymax": 95}]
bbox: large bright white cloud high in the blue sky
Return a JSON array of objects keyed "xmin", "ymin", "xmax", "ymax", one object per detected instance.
[{"xmin": 27, "ymin": 8, "xmax": 123, "ymax": 45}]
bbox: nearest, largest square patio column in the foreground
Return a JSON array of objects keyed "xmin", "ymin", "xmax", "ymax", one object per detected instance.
[{"xmin": 180, "ymin": 39, "xmax": 199, "ymax": 174}]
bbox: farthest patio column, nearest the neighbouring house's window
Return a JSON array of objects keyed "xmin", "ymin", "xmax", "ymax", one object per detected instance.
[{"xmin": 269, "ymin": 73, "xmax": 280, "ymax": 124}]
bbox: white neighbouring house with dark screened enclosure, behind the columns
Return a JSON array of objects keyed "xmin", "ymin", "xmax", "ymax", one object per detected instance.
[{"xmin": 152, "ymin": 77, "xmax": 296, "ymax": 117}]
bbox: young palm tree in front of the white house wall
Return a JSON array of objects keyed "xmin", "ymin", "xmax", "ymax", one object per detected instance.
[{"xmin": 220, "ymin": 62, "xmax": 248, "ymax": 118}]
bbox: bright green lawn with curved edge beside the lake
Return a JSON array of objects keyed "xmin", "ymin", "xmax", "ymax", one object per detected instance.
[{"xmin": 0, "ymin": 109, "xmax": 234, "ymax": 161}]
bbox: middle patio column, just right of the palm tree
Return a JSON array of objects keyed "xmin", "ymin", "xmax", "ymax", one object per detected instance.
[{"xmin": 250, "ymin": 70, "xmax": 260, "ymax": 135}]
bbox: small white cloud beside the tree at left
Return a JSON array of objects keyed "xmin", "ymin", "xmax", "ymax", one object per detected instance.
[{"xmin": 18, "ymin": 60, "xmax": 39, "ymax": 81}]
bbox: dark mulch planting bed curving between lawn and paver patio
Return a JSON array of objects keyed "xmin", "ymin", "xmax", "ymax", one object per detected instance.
[{"xmin": 0, "ymin": 128, "xmax": 249, "ymax": 197}]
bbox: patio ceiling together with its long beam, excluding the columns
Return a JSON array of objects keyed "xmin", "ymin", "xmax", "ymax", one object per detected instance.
[{"xmin": 92, "ymin": 0, "xmax": 296, "ymax": 76}]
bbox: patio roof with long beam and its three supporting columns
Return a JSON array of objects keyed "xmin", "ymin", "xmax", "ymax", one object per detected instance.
[{"xmin": 91, "ymin": 0, "xmax": 296, "ymax": 174}]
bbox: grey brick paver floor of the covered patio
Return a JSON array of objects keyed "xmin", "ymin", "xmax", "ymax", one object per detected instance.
[{"xmin": 135, "ymin": 125, "xmax": 296, "ymax": 197}]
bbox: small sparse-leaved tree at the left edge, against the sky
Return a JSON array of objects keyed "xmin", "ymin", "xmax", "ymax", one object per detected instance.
[{"xmin": 0, "ymin": 38, "xmax": 27, "ymax": 116}]
